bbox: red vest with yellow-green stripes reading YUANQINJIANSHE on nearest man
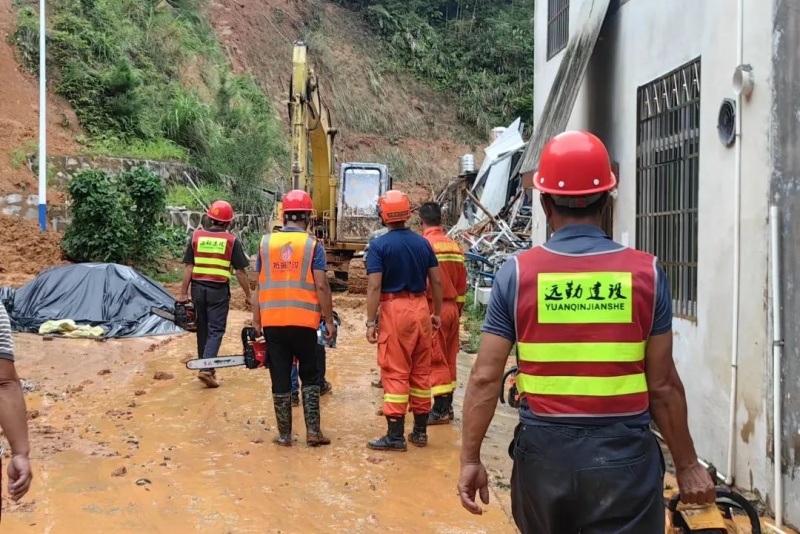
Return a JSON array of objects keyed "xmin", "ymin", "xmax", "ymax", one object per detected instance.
[{"xmin": 516, "ymin": 247, "xmax": 656, "ymax": 418}]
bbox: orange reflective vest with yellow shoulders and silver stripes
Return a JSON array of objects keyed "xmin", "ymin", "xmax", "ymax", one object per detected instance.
[{"xmin": 258, "ymin": 232, "xmax": 322, "ymax": 330}]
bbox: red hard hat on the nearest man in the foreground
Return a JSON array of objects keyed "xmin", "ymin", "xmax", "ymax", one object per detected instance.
[{"xmin": 533, "ymin": 131, "xmax": 617, "ymax": 197}]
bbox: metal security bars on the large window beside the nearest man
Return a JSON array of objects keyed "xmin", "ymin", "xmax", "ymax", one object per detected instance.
[{"xmin": 636, "ymin": 58, "xmax": 700, "ymax": 320}]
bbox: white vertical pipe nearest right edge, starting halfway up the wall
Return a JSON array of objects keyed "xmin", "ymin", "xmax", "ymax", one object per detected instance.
[{"xmin": 769, "ymin": 206, "xmax": 783, "ymax": 527}]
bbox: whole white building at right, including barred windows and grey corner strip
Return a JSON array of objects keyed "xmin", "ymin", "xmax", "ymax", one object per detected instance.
[{"xmin": 522, "ymin": 0, "xmax": 800, "ymax": 525}]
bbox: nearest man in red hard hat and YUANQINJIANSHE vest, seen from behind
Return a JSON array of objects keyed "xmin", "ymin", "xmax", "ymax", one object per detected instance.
[{"xmin": 458, "ymin": 132, "xmax": 715, "ymax": 534}]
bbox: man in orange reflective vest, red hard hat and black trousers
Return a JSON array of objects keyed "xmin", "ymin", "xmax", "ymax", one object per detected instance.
[{"xmin": 253, "ymin": 190, "xmax": 336, "ymax": 447}]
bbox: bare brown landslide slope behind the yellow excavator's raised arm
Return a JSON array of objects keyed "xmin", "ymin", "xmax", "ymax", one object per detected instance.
[{"xmin": 210, "ymin": 0, "xmax": 484, "ymax": 200}]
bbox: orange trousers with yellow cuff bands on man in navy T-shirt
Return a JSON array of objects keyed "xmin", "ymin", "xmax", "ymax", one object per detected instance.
[{"xmin": 378, "ymin": 293, "xmax": 433, "ymax": 417}]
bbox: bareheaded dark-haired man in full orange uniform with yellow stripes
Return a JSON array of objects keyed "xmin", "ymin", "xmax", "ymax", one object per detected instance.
[{"xmin": 419, "ymin": 202, "xmax": 467, "ymax": 425}]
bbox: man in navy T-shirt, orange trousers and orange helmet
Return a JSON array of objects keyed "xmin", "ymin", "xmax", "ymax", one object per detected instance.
[{"xmin": 366, "ymin": 190, "xmax": 442, "ymax": 451}]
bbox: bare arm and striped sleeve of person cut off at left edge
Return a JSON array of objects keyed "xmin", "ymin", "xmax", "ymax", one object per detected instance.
[{"xmin": 0, "ymin": 304, "xmax": 33, "ymax": 501}]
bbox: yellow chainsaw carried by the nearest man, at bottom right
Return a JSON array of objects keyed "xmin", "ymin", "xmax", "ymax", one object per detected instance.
[{"xmin": 666, "ymin": 486, "xmax": 761, "ymax": 534}]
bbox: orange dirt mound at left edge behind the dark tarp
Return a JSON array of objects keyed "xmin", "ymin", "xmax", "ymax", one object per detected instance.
[{"xmin": 0, "ymin": 215, "xmax": 69, "ymax": 279}]
